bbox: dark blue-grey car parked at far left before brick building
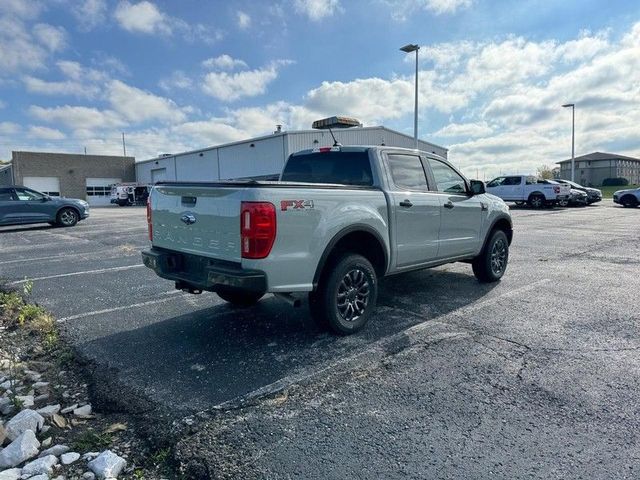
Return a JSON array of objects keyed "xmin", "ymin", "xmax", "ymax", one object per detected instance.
[{"xmin": 0, "ymin": 186, "xmax": 89, "ymax": 227}]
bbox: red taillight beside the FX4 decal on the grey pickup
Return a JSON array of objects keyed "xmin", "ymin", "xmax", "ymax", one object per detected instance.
[{"xmin": 240, "ymin": 202, "xmax": 276, "ymax": 258}]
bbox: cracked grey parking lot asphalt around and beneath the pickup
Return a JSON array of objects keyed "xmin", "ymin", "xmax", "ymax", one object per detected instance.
[{"xmin": 0, "ymin": 201, "xmax": 640, "ymax": 478}]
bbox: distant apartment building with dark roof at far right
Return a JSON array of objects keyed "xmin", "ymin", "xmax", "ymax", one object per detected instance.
[{"xmin": 557, "ymin": 152, "xmax": 640, "ymax": 187}]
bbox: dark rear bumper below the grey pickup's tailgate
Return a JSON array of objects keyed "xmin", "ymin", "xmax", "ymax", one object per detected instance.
[{"xmin": 142, "ymin": 248, "xmax": 267, "ymax": 293}]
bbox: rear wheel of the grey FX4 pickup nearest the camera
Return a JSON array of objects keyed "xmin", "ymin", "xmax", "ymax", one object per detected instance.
[{"xmin": 309, "ymin": 254, "xmax": 378, "ymax": 335}]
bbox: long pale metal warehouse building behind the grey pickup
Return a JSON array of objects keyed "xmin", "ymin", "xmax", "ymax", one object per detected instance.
[{"xmin": 136, "ymin": 127, "xmax": 447, "ymax": 183}]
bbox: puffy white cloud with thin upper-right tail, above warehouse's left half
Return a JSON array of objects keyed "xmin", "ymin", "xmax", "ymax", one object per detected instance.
[{"xmin": 202, "ymin": 60, "xmax": 291, "ymax": 102}]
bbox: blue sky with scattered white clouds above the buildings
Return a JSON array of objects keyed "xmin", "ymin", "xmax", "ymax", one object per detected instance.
[{"xmin": 0, "ymin": 0, "xmax": 640, "ymax": 178}]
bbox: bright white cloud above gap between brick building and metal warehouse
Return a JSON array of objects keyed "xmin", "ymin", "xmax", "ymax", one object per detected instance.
[{"xmin": 107, "ymin": 80, "xmax": 185, "ymax": 123}]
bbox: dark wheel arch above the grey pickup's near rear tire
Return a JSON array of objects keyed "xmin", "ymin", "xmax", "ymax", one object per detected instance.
[{"xmin": 313, "ymin": 224, "xmax": 389, "ymax": 289}]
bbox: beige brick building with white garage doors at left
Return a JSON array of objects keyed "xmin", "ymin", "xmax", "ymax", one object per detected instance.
[{"xmin": 11, "ymin": 152, "xmax": 135, "ymax": 205}]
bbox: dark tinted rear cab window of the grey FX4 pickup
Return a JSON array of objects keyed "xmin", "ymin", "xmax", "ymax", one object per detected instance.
[{"xmin": 281, "ymin": 150, "xmax": 373, "ymax": 186}]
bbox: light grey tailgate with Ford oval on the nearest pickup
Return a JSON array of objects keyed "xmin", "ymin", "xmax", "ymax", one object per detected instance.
[{"xmin": 150, "ymin": 185, "xmax": 244, "ymax": 262}]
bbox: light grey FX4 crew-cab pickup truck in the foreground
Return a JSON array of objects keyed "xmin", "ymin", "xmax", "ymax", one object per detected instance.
[{"xmin": 142, "ymin": 146, "xmax": 513, "ymax": 334}]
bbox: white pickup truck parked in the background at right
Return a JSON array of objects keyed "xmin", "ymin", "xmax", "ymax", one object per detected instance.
[{"xmin": 487, "ymin": 175, "xmax": 571, "ymax": 208}]
